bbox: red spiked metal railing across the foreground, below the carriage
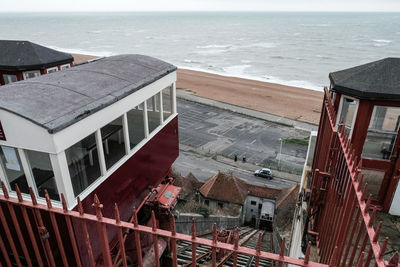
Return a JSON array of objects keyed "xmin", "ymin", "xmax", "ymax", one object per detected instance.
[{"xmin": 0, "ymin": 181, "xmax": 333, "ymax": 267}]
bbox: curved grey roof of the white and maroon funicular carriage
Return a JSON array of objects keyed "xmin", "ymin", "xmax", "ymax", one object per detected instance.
[{"xmin": 0, "ymin": 55, "xmax": 176, "ymax": 133}]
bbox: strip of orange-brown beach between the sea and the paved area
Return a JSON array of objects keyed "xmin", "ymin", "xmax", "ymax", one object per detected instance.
[{"xmin": 72, "ymin": 54, "xmax": 323, "ymax": 124}]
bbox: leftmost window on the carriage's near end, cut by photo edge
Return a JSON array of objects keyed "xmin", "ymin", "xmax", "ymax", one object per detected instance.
[{"xmin": 0, "ymin": 146, "xmax": 29, "ymax": 194}]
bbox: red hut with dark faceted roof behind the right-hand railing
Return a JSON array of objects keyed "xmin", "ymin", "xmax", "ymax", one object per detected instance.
[{"xmin": 313, "ymin": 58, "xmax": 400, "ymax": 214}]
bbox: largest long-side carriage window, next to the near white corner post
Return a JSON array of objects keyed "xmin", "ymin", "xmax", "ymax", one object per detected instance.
[{"xmin": 65, "ymin": 133, "xmax": 101, "ymax": 196}]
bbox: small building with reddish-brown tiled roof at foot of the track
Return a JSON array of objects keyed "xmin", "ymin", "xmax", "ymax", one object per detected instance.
[{"xmin": 199, "ymin": 172, "xmax": 282, "ymax": 227}]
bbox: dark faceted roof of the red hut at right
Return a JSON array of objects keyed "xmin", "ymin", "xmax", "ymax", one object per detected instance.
[{"xmin": 329, "ymin": 58, "xmax": 400, "ymax": 100}]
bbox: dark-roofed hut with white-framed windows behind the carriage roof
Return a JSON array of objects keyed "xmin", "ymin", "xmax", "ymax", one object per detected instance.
[{"xmin": 0, "ymin": 40, "xmax": 74, "ymax": 85}]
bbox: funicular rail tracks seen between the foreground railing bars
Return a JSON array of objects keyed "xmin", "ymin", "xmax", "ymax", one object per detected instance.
[{"xmin": 177, "ymin": 227, "xmax": 273, "ymax": 267}]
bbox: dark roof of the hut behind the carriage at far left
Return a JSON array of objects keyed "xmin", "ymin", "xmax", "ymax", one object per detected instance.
[{"xmin": 0, "ymin": 40, "xmax": 74, "ymax": 71}]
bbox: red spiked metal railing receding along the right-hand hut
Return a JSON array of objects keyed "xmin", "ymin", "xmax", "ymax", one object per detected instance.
[{"xmin": 310, "ymin": 89, "xmax": 399, "ymax": 266}]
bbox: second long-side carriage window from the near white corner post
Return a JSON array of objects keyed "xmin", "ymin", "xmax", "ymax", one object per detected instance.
[{"xmin": 101, "ymin": 117, "xmax": 125, "ymax": 169}]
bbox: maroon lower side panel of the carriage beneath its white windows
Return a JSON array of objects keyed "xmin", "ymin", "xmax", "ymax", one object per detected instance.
[{"xmin": 73, "ymin": 117, "xmax": 179, "ymax": 267}]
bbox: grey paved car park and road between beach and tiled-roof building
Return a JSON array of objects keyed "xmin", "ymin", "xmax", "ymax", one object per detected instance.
[{"xmin": 174, "ymin": 98, "xmax": 309, "ymax": 188}]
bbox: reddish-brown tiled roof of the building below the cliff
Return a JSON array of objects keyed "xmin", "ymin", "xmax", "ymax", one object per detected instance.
[{"xmin": 199, "ymin": 172, "xmax": 282, "ymax": 205}]
